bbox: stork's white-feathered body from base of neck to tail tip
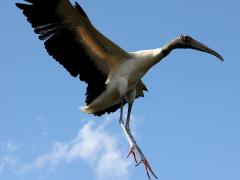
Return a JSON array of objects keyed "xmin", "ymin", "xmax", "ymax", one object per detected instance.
[{"xmin": 81, "ymin": 48, "xmax": 162, "ymax": 114}]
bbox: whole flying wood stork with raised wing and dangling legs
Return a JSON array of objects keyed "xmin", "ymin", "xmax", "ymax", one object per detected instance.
[{"xmin": 16, "ymin": 0, "xmax": 223, "ymax": 179}]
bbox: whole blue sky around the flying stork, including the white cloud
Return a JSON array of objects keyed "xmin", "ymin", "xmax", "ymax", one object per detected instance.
[{"xmin": 0, "ymin": 0, "xmax": 240, "ymax": 180}]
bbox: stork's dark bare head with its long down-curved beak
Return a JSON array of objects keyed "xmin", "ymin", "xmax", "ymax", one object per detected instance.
[{"xmin": 174, "ymin": 35, "xmax": 224, "ymax": 61}]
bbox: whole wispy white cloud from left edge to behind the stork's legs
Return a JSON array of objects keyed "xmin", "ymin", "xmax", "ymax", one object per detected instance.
[{"xmin": 0, "ymin": 112, "xmax": 142, "ymax": 180}]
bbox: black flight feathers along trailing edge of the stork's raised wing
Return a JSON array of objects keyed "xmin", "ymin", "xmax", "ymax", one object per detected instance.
[{"xmin": 16, "ymin": 0, "xmax": 132, "ymax": 116}]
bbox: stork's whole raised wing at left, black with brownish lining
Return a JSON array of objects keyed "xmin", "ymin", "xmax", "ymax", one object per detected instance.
[{"xmin": 16, "ymin": 0, "xmax": 129, "ymax": 114}]
